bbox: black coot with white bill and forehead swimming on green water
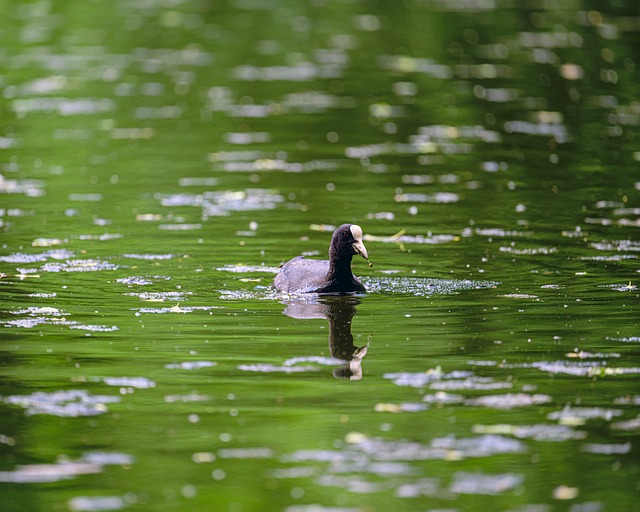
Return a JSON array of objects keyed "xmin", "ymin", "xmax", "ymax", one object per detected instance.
[{"xmin": 273, "ymin": 224, "xmax": 369, "ymax": 293}]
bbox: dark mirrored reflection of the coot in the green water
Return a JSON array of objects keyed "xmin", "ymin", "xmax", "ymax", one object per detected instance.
[{"xmin": 283, "ymin": 295, "xmax": 369, "ymax": 380}]
